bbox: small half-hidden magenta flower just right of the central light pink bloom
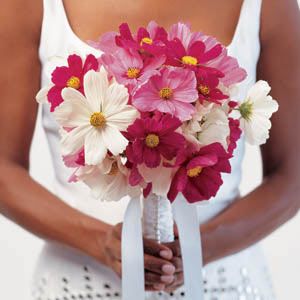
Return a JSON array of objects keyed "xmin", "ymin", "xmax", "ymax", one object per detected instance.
[{"xmin": 196, "ymin": 72, "xmax": 228, "ymax": 104}]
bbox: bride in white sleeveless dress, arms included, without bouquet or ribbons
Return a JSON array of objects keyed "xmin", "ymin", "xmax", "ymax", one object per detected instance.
[{"xmin": 0, "ymin": 0, "xmax": 300, "ymax": 300}]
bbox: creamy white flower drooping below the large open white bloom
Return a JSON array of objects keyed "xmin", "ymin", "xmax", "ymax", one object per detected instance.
[{"xmin": 76, "ymin": 156, "xmax": 141, "ymax": 201}]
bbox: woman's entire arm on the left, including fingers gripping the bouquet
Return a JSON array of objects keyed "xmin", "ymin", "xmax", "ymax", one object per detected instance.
[{"xmin": 0, "ymin": 0, "xmax": 178, "ymax": 289}]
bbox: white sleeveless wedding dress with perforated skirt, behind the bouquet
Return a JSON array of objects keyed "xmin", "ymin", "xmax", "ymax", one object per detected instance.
[{"xmin": 32, "ymin": 0, "xmax": 275, "ymax": 300}]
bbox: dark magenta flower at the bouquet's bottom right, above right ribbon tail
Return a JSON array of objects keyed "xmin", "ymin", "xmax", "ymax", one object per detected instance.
[{"xmin": 168, "ymin": 143, "xmax": 231, "ymax": 203}]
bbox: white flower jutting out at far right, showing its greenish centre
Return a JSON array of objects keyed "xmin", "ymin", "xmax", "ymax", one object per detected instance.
[{"xmin": 238, "ymin": 80, "xmax": 278, "ymax": 145}]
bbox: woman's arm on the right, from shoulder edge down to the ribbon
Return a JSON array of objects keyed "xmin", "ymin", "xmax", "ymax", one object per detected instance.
[{"xmin": 201, "ymin": 0, "xmax": 300, "ymax": 263}]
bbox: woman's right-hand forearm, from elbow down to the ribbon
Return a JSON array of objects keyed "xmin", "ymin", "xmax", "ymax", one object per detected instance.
[{"xmin": 201, "ymin": 172, "xmax": 300, "ymax": 264}]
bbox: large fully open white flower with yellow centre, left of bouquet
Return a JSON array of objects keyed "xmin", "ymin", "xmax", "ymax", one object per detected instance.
[{"xmin": 53, "ymin": 67, "xmax": 138, "ymax": 165}]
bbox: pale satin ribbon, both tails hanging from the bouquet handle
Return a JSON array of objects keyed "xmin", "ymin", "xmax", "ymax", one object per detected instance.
[{"xmin": 122, "ymin": 194, "xmax": 204, "ymax": 300}]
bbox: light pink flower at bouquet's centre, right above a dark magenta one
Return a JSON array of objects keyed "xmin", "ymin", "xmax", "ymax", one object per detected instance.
[{"xmin": 132, "ymin": 67, "xmax": 198, "ymax": 121}]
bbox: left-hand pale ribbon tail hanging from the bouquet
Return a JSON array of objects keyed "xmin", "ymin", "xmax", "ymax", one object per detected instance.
[{"xmin": 122, "ymin": 198, "xmax": 145, "ymax": 300}]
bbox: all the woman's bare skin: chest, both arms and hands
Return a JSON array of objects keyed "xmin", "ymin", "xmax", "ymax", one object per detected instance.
[{"xmin": 0, "ymin": 0, "xmax": 300, "ymax": 291}]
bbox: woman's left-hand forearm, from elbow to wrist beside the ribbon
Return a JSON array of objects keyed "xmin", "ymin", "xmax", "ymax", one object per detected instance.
[{"xmin": 0, "ymin": 161, "xmax": 110, "ymax": 261}]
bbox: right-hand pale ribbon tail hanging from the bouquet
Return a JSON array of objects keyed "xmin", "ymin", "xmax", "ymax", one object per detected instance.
[{"xmin": 172, "ymin": 195, "xmax": 204, "ymax": 300}]
